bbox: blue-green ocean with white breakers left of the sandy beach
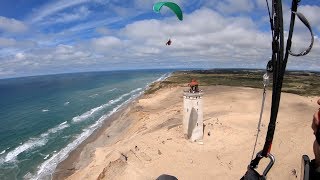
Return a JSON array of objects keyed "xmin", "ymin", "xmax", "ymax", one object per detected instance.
[{"xmin": 0, "ymin": 70, "xmax": 170, "ymax": 180}]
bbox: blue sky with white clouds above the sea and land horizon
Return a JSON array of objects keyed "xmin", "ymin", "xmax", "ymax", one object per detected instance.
[{"xmin": 0, "ymin": 0, "xmax": 320, "ymax": 78}]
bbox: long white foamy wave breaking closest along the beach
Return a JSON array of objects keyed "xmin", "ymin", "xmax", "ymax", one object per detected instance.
[{"xmin": 31, "ymin": 88, "xmax": 142, "ymax": 179}]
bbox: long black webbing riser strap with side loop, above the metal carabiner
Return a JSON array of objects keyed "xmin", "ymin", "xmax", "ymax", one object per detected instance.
[{"xmin": 249, "ymin": 0, "xmax": 314, "ymax": 174}]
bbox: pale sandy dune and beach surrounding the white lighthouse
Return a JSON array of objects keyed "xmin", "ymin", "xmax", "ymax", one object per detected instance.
[{"xmin": 54, "ymin": 86, "xmax": 318, "ymax": 180}]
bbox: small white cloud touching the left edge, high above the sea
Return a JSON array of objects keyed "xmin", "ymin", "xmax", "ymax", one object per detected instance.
[{"xmin": 0, "ymin": 16, "xmax": 28, "ymax": 33}]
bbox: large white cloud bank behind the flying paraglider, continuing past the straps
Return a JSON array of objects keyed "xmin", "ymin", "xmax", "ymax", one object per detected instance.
[{"xmin": 115, "ymin": 9, "xmax": 320, "ymax": 68}]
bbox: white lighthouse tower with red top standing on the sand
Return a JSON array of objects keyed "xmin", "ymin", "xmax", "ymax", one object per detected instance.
[{"xmin": 183, "ymin": 79, "xmax": 203, "ymax": 142}]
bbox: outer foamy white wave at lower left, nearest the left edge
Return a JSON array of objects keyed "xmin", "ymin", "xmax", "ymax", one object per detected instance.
[{"xmin": 4, "ymin": 121, "xmax": 69, "ymax": 162}]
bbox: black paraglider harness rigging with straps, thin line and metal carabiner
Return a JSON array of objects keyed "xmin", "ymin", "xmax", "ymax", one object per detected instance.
[{"xmin": 241, "ymin": 0, "xmax": 312, "ymax": 180}]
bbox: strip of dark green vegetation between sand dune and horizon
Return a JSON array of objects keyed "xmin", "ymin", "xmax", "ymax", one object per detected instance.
[{"xmin": 146, "ymin": 69, "xmax": 320, "ymax": 96}]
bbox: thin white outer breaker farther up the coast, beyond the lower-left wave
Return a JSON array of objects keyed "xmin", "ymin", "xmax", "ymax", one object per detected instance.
[{"xmin": 72, "ymin": 88, "xmax": 141, "ymax": 122}]
